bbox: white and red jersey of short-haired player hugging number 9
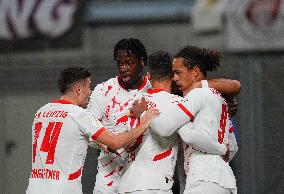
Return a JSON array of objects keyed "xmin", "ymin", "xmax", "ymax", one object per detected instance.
[{"xmin": 119, "ymin": 89, "xmax": 225, "ymax": 194}]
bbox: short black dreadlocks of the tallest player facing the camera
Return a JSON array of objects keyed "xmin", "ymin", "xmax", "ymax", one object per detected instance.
[{"xmin": 113, "ymin": 38, "xmax": 148, "ymax": 66}]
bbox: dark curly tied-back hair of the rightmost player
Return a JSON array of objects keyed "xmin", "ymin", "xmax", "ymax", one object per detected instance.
[{"xmin": 175, "ymin": 46, "xmax": 223, "ymax": 76}]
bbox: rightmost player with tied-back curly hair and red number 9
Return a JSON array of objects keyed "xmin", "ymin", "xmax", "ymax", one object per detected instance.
[{"xmin": 150, "ymin": 46, "xmax": 240, "ymax": 194}]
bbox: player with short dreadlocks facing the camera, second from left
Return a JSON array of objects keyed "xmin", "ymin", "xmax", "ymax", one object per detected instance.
[{"xmin": 88, "ymin": 38, "xmax": 151, "ymax": 194}]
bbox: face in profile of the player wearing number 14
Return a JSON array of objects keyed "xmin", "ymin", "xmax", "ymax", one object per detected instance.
[{"xmin": 79, "ymin": 78, "xmax": 91, "ymax": 108}]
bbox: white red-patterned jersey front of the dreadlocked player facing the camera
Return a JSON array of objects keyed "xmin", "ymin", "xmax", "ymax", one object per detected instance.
[{"xmin": 88, "ymin": 77, "xmax": 151, "ymax": 194}]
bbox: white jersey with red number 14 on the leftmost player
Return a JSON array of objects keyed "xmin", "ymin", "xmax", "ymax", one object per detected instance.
[{"xmin": 26, "ymin": 100, "xmax": 106, "ymax": 194}]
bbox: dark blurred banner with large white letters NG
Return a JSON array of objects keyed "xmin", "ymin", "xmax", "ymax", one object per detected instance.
[{"xmin": 0, "ymin": 0, "xmax": 83, "ymax": 52}]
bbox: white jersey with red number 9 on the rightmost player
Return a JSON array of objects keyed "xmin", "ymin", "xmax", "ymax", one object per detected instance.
[{"xmin": 182, "ymin": 88, "xmax": 236, "ymax": 192}]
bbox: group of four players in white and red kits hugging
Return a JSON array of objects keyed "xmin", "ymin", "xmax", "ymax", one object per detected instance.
[{"xmin": 26, "ymin": 38, "xmax": 240, "ymax": 194}]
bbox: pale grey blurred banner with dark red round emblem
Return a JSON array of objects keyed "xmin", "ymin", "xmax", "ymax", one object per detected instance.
[{"xmin": 225, "ymin": 0, "xmax": 284, "ymax": 52}]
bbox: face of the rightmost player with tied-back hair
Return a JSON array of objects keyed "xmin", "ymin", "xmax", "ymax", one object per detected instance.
[{"xmin": 172, "ymin": 58, "xmax": 193, "ymax": 95}]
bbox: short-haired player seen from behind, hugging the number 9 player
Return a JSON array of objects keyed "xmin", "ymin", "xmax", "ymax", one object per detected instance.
[{"xmin": 119, "ymin": 51, "xmax": 231, "ymax": 194}]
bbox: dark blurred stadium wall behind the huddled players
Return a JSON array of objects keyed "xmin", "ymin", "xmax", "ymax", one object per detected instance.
[{"xmin": 0, "ymin": 0, "xmax": 284, "ymax": 194}]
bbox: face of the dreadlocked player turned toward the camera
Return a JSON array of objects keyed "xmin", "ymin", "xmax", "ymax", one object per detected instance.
[{"xmin": 116, "ymin": 50, "xmax": 143, "ymax": 87}]
